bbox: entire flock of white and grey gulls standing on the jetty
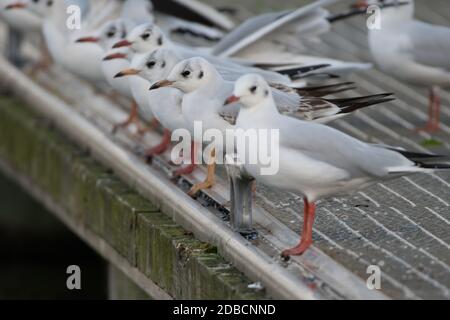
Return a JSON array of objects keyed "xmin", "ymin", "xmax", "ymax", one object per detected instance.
[{"xmin": 0, "ymin": 0, "xmax": 450, "ymax": 257}]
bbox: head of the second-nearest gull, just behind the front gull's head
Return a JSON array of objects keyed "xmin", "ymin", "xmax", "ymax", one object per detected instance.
[{"xmin": 151, "ymin": 57, "xmax": 219, "ymax": 93}]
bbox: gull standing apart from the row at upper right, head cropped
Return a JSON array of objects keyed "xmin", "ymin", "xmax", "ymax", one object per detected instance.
[{"xmin": 355, "ymin": 0, "xmax": 450, "ymax": 132}]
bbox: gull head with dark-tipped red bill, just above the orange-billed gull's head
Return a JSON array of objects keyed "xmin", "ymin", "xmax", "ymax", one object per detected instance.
[{"xmin": 113, "ymin": 23, "xmax": 166, "ymax": 53}]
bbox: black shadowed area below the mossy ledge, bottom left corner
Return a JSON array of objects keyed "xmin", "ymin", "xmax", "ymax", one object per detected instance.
[{"xmin": 0, "ymin": 174, "xmax": 108, "ymax": 300}]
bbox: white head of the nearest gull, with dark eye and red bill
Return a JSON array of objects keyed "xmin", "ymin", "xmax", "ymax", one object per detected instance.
[{"xmin": 225, "ymin": 74, "xmax": 272, "ymax": 109}]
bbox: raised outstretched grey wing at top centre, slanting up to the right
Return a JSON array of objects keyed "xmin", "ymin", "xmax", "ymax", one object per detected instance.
[{"xmin": 213, "ymin": 0, "xmax": 336, "ymax": 56}]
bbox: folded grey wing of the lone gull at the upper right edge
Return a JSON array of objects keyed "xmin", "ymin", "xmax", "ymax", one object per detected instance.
[{"xmin": 408, "ymin": 21, "xmax": 450, "ymax": 69}]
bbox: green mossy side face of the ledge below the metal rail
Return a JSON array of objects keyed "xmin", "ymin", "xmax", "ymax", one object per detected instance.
[{"xmin": 0, "ymin": 97, "xmax": 266, "ymax": 299}]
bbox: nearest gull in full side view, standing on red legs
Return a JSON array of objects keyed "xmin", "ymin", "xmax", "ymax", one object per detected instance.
[{"xmin": 225, "ymin": 74, "xmax": 450, "ymax": 258}]
